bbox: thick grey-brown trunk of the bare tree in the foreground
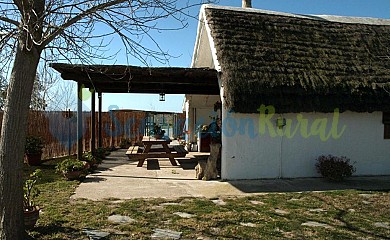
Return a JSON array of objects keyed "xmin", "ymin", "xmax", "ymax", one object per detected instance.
[{"xmin": 0, "ymin": 40, "xmax": 41, "ymax": 240}]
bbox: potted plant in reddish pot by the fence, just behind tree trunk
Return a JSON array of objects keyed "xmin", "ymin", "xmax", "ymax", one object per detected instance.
[{"xmin": 24, "ymin": 136, "xmax": 44, "ymax": 166}]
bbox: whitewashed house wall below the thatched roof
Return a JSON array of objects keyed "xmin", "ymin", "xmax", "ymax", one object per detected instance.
[{"xmin": 222, "ymin": 111, "xmax": 390, "ymax": 179}]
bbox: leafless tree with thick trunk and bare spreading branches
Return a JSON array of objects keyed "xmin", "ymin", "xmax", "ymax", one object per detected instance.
[{"xmin": 0, "ymin": 0, "xmax": 213, "ymax": 240}]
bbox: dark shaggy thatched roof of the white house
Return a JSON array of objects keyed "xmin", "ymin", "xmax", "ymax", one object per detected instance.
[{"xmin": 204, "ymin": 6, "xmax": 390, "ymax": 113}]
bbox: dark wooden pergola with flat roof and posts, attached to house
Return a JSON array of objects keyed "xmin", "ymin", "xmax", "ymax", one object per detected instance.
[{"xmin": 51, "ymin": 63, "xmax": 220, "ymax": 158}]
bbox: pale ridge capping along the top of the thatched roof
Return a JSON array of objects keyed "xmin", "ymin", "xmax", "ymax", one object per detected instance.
[{"xmin": 201, "ymin": 4, "xmax": 390, "ymax": 25}]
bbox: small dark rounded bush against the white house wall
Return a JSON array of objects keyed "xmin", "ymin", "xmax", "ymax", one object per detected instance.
[{"xmin": 316, "ymin": 155, "xmax": 356, "ymax": 181}]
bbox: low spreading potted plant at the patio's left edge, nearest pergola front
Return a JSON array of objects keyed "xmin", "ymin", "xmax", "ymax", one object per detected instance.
[{"xmin": 56, "ymin": 158, "xmax": 86, "ymax": 180}]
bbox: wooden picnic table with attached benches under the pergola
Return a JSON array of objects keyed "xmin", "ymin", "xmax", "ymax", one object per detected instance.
[{"xmin": 126, "ymin": 137, "xmax": 187, "ymax": 167}]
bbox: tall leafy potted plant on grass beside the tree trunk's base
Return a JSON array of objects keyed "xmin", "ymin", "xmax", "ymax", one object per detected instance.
[{"xmin": 23, "ymin": 169, "xmax": 42, "ymax": 229}]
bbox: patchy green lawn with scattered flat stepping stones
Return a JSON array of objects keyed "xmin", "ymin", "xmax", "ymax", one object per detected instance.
[{"xmin": 26, "ymin": 161, "xmax": 390, "ymax": 240}]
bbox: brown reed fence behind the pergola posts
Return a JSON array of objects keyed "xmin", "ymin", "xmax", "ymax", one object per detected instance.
[{"xmin": 0, "ymin": 111, "xmax": 185, "ymax": 158}]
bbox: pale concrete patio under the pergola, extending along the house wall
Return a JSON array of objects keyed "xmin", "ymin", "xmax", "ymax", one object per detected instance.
[{"xmin": 72, "ymin": 149, "xmax": 390, "ymax": 200}]
